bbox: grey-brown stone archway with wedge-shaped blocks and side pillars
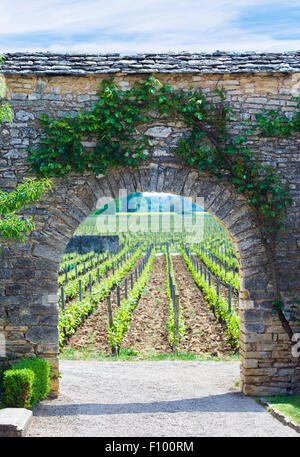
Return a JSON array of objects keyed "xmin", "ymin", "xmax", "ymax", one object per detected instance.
[{"xmin": 1, "ymin": 158, "xmax": 295, "ymax": 395}]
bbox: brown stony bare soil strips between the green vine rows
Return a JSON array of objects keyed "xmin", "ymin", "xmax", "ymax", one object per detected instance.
[{"xmin": 65, "ymin": 255, "xmax": 234, "ymax": 358}]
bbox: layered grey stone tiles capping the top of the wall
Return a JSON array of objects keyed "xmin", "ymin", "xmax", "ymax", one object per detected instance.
[{"xmin": 2, "ymin": 51, "xmax": 300, "ymax": 75}]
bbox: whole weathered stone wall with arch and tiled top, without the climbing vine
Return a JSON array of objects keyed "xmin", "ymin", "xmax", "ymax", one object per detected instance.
[{"xmin": 0, "ymin": 53, "xmax": 300, "ymax": 395}]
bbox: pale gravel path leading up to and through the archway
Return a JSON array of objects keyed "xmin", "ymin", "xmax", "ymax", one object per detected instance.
[{"xmin": 28, "ymin": 360, "xmax": 299, "ymax": 437}]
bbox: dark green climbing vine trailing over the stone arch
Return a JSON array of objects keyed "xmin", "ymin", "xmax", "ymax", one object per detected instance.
[{"xmin": 29, "ymin": 76, "xmax": 300, "ymax": 339}]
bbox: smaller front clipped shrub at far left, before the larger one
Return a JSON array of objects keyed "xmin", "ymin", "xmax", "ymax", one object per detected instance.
[{"xmin": 3, "ymin": 368, "xmax": 35, "ymax": 408}]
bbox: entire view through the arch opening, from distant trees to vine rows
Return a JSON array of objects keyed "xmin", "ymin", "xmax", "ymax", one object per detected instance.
[{"xmin": 59, "ymin": 187, "xmax": 239, "ymax": 360}]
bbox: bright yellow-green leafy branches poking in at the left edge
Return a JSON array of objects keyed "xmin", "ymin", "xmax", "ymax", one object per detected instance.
[{"xmin": 0, "ymin": 56, "xmax": 51, "ymax": 241}]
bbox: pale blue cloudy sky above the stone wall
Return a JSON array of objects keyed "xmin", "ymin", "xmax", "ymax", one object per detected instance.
[{"xmin": 0, "ymin": 0, "xmax": 300, "ymax": 55}]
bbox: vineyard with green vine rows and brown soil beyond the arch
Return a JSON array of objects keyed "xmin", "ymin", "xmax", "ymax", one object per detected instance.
[{"xmin": 59, "ymin": 215, "xmax": 239, "ymax": 358}]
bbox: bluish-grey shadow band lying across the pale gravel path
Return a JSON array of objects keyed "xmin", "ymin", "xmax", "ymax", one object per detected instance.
[{"xmin": 33, "ymin": 392, "xmax": 265, "ymax": 417}]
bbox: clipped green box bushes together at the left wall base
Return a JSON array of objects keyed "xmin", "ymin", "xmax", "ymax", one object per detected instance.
[{"xmin": 3, "ymin": 357, "xmax": 50, "ymax": 408}]
